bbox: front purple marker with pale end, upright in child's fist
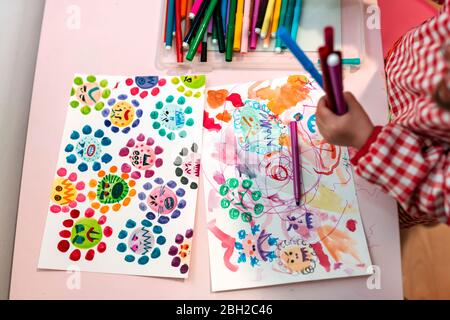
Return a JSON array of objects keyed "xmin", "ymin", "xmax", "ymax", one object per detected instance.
[{"xmin": 327, "ymin": 53, "xmax": 348, "ymax": 116}]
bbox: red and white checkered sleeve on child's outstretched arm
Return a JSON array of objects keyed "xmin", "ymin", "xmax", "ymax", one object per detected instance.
[{"xmin": 352, "ymin": 124, "xmax": 450, "ymax": 224}]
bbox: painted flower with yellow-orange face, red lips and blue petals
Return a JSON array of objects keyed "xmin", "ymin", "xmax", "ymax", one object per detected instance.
[{"xmin": 102, "ymin": 94, "xmax": 143, "ymax": 133}]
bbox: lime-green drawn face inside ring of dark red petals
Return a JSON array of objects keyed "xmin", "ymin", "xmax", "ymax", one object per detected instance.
[{"xmin": 70, "ymin": 218, "xmax": 102, "ymax": 249}]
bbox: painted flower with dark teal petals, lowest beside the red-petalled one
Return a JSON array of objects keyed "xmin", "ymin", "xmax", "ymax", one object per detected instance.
[{"xmin": 117, "ymin": 219, "xmax": 166, "ymax": 265}]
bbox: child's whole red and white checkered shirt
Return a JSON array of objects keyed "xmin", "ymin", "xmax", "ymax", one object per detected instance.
[{"xmin": 352, "ymin": 0, "xmax": 450, "ymax": 227}]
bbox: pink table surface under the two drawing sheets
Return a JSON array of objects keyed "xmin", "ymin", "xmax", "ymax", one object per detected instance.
[{"xmin": 10, "ymin": 0, "xmax": 402, "ymax": 299}]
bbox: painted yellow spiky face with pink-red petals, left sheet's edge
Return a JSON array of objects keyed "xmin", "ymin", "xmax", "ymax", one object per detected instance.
[{"xmin": 50, "ymin": 168, "xmax": 86, "ymax": 213}]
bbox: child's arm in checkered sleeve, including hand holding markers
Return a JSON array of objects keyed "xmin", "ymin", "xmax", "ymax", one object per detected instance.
[{"xmin": 316, "ymin": 93, "xmax": 450, "ymax": 224}]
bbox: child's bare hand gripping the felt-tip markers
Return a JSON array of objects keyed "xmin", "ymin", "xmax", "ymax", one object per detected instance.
[{"xmin": 316, "ymin": 92, "xmax": 374, "ymax": 149}]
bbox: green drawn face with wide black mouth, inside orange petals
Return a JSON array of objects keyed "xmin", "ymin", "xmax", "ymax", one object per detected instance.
[{"xmin": 97, "ymin": 174, "xmax": 129, "ymax": 204}]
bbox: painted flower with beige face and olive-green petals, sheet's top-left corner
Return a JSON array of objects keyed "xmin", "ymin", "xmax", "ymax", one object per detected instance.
[{"xmin": 70, "ymin": 75, "xmax": 111, "ymax": 115}]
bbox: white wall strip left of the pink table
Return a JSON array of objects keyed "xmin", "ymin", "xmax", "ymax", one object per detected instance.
[{"xmin": 0, "ymin": 0, "xmax": 45, "ymax": 299}]
